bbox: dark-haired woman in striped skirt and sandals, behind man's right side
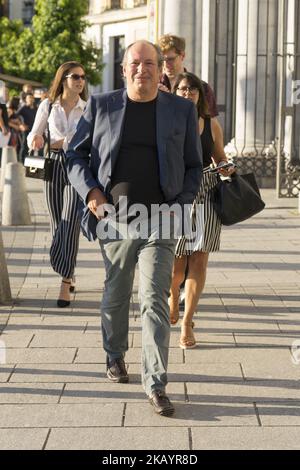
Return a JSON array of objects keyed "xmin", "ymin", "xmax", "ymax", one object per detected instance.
[{"xmin": 169, "ymin": 72, "xmax": 234, "ymax": 349}]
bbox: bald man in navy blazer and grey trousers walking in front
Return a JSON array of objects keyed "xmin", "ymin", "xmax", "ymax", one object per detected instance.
[{"xmin": 67, "ymin": 41, "xmax": 202, "ymax": 416}]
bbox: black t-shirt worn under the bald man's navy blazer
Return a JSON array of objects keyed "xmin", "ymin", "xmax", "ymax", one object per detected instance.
[{"xmin": 111, "ymin": 98, "xmax": 164, "ymax": 221}]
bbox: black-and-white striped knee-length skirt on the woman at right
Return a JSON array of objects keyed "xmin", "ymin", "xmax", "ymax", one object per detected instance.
[{"xmin": 175, "ymin": 172, "xmax": 221, "ymax": 258}]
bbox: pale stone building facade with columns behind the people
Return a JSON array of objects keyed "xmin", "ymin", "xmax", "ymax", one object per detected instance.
[{"xmin": 87, "ymin": 0, "xmax": 300, "ymax": 193}]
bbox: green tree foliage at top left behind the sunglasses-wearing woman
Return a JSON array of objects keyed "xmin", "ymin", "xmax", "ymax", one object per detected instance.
[{"xmin": 0, "ymin": 0, "xmax": 103, "ymax": 86}]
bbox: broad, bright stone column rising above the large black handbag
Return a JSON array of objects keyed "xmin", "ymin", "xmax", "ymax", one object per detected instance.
[{"xmin": 234, "ymin": 0, "xmax": 278, "ymax": 158}]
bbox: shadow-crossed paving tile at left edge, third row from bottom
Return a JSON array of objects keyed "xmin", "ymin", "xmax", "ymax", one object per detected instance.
[{"xmin": 0, "ymin": 383, "xmax": 63, "ymax": 404}]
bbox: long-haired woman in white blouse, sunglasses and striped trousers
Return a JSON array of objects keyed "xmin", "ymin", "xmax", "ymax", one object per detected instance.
[{"xmin": 28, "ymin": 62, "xmax": 87, "ymax": 307}]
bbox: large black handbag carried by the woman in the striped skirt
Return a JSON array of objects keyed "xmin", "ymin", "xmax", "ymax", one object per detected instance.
[{"xmin": 212, "ymin": 173, "xmax": 265, "ymax": 225}]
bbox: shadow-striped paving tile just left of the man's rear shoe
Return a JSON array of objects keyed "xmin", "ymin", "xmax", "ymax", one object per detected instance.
[{"xmin": 9, "ymin": 364, "xmax": 108, "ymax": 383}]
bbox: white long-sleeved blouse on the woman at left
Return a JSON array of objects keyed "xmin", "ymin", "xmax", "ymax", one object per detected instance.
[{"xmin": 27, "ymin": 97, "xmax": 86, "ymax": 150}]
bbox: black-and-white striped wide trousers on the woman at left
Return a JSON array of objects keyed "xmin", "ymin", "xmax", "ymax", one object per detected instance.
[{"xmin": 45, "ymin": 151, "xmax": 80, "ymax": 278}]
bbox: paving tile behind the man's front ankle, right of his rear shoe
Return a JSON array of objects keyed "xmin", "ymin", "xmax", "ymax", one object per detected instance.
[{"xmin": 128, "ymin": 363, "xmax": 244, "ymax": 383}]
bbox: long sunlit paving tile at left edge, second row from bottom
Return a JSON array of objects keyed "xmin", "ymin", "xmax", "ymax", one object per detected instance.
[{"xmin": 0, "ymin": 403, "xmax": 124, "ymax": 428}]
